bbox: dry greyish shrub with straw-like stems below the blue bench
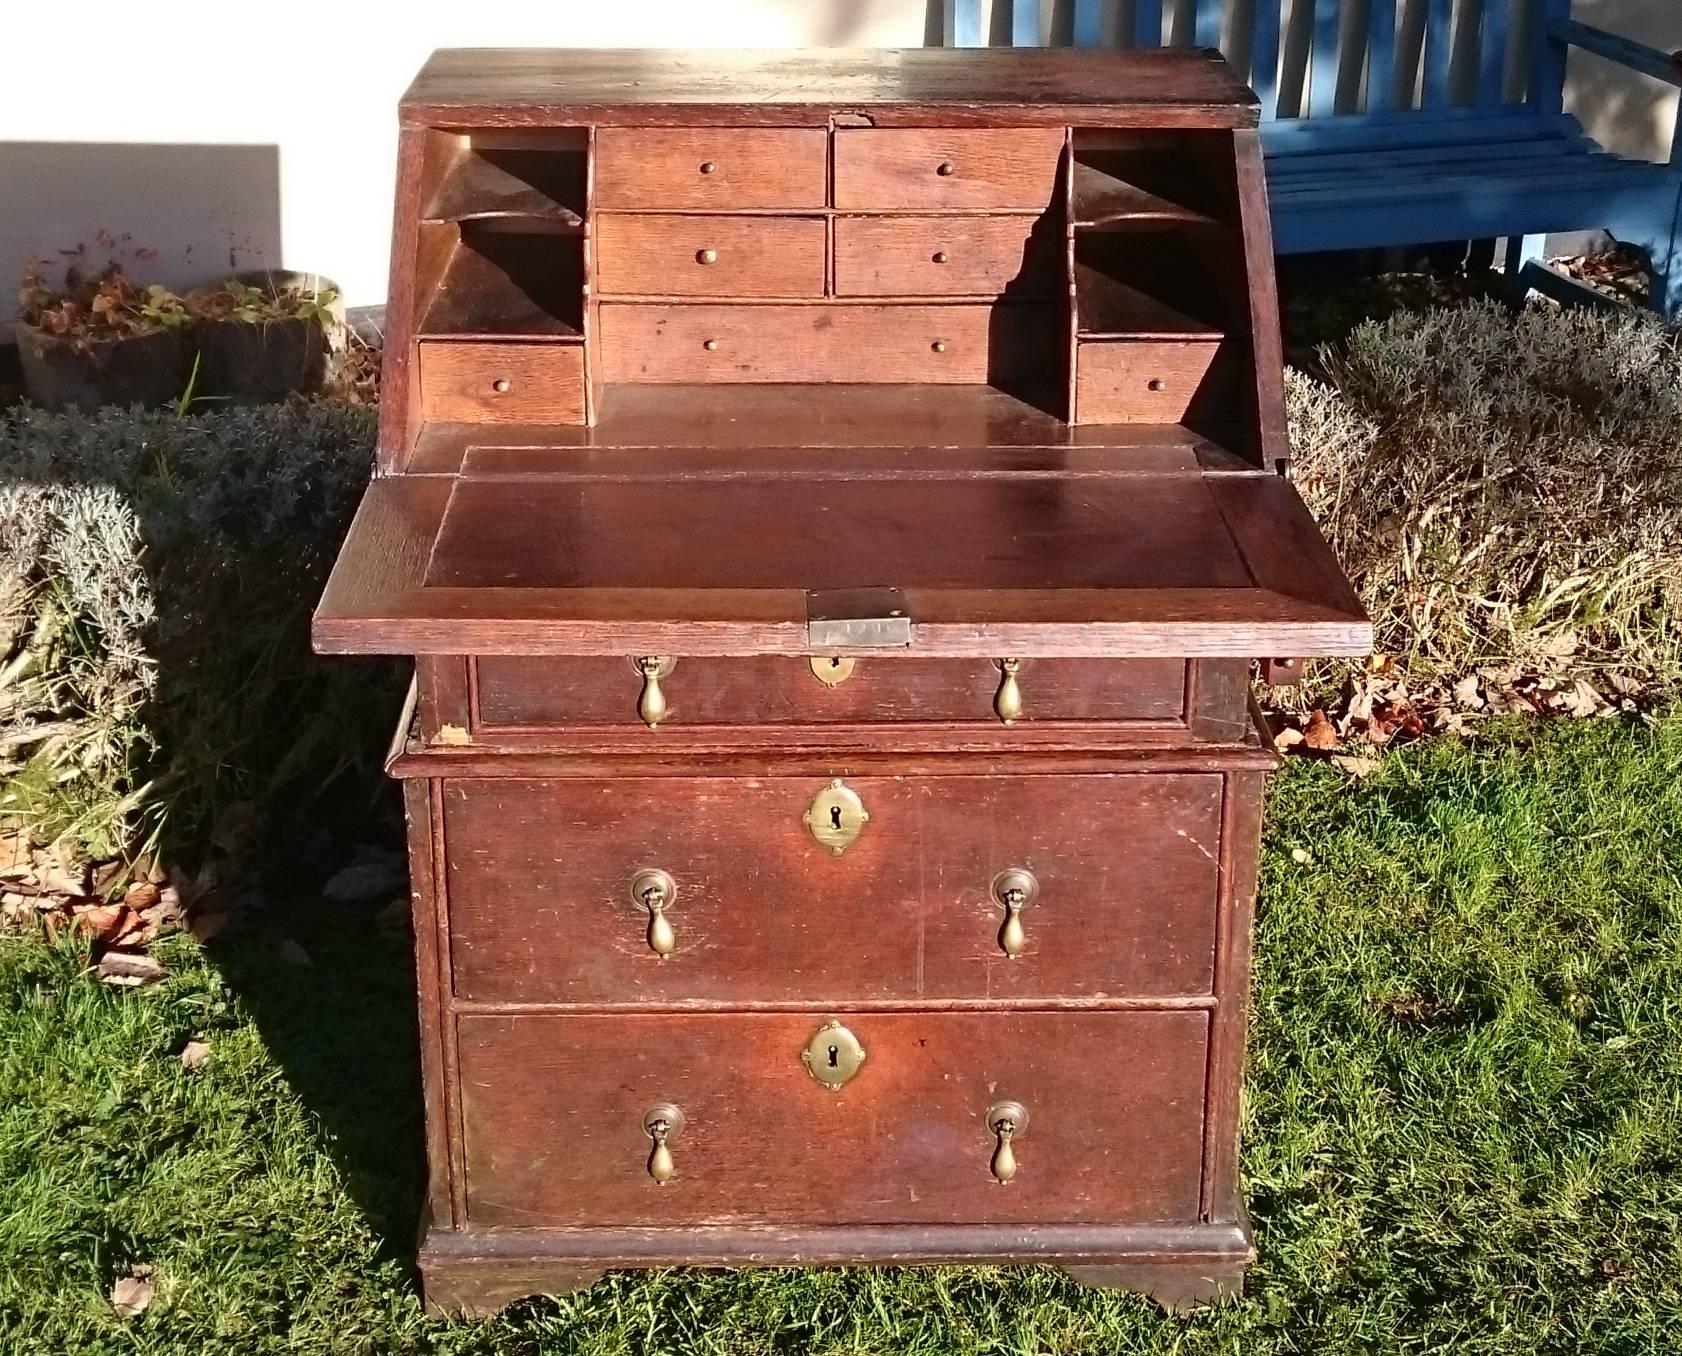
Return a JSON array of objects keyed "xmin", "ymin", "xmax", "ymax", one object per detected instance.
[{"xmin": 1288, "ymin": 303, "xmax": 1682, "ymax": 723}]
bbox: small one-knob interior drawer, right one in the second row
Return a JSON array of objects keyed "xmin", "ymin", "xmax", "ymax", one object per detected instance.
[{"xmin": 836, "ymin": 217, "xmax": 1063, "ymax": 296}]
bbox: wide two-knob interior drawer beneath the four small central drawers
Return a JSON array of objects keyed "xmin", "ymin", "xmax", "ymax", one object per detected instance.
[{"xmin": 597, "ymin": 303, "xmax": 1056, "ymax": 384}]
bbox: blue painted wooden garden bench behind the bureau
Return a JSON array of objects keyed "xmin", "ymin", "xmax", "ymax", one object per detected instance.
[{"xmin": 945, "ymin": 0, "xmax": 1682, "ymax": 320}]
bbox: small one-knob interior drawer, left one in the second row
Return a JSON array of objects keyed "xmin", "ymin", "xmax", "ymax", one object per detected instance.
[{"xmin": 595, "ymin": 212, "xmax": 824, "ymax": 296}]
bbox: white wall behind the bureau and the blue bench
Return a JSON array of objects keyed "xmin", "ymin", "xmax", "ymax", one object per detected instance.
[{"xmin": 0, "ymin": 0, "xmax": 1682, "ymax": 315}]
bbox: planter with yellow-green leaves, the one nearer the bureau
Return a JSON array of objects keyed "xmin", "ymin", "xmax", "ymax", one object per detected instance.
[{"xmin": 188, "ymin": 269, "xmax": 340, "ymax": 404}]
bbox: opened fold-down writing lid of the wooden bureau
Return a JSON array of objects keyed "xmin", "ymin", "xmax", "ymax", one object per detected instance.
[{"xmin": 315, "ymin": 449, "xmax": 1373, "ymax": 658}]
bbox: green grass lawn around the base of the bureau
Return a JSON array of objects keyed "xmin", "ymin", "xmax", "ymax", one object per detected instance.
[{"xmin": 0, "ymin": 715, "xmax": 1682, "ymax": 1356}]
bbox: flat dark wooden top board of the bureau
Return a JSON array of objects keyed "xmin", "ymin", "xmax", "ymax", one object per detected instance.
[{"xmin": 402, "ymin": 47, "xmax": 1256, "ymax": 128}]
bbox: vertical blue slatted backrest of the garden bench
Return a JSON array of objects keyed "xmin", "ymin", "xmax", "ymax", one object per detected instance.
[{"xmin": 945, "ymin": 0, "xmax": 1571, "ymax": 119}]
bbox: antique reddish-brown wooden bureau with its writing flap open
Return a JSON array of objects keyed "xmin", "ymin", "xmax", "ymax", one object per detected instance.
[{"xmin": 315, "ymin": 50, "xmax": 1369, "ymax": 1309}]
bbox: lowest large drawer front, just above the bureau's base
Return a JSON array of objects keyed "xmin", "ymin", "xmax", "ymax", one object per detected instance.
[{"xmin": 458, "ymin": 1009, "xmax": 1208, "ymax": 1228}]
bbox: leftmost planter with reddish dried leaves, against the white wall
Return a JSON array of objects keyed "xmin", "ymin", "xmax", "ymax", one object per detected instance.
[{"xmin": 17, "ymin": 259, "xmax": 192, "ymax": 411}]
